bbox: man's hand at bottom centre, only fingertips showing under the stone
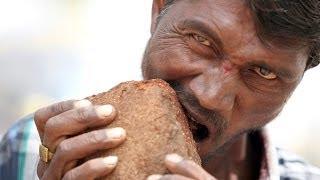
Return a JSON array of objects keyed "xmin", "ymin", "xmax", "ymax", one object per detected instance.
[{"xmin": 147, "ymin": 154, "xmax": 216, "ymax": 180}]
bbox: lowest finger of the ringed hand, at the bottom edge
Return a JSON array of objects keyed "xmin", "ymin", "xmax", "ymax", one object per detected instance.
[{"xmin": 62, "ymin": 156, "xmax": 118, "ymax": 180}]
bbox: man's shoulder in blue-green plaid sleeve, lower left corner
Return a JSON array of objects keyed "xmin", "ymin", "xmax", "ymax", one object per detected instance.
[{"xmin": 0, "ymin": 115, "xmax": 40, "ymax": 179}]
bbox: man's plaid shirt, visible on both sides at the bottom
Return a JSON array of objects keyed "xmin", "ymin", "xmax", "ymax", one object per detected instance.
[{"xmin": 0, "ymin": 115, "xmax": 320, "ymax": 180}]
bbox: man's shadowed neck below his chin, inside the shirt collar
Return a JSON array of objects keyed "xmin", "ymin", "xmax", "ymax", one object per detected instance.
[{"xmin": 204, "ymin": 134, "xmax": 261, "ymax": 180}]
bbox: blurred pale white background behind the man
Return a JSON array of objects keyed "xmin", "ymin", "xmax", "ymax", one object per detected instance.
[{"xmin": 0, "ymin": 0, "xmax": 320, "ymax": 166}]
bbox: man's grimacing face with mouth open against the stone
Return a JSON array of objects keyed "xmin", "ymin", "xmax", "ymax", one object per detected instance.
[{"xmin": 142, "ymin": 0, "xmax": 307, "ymax": 158}]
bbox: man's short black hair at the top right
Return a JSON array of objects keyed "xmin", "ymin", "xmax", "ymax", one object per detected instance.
[{"xmin": 164, "ymin": 0, "xmax": 320, "ymax": 69}]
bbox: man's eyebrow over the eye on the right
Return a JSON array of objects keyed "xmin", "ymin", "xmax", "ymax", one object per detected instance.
[{"xmin": 251, "ymin": 60, "xmax": 294, "ymax": 80}]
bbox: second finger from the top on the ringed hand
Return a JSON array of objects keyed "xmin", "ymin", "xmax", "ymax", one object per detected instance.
[{"xmin": 43, "ymin": 105, "xmax": 116, "ymax": 152}]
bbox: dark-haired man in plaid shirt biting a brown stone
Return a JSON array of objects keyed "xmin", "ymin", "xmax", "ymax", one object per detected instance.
[{"xmin": 0, "ymin": 0, "xmax": 320, "ymax": 180}]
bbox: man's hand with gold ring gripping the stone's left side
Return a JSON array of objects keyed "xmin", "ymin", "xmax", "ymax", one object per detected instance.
[{"xmin": 34, "ymin": 100, "xmax": 126, "ymax": 180}]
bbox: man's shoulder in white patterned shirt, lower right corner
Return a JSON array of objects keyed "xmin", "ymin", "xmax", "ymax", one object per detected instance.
[{"xmin": 276, "ymin": 148, "xmax": 320, "ymax": 180}]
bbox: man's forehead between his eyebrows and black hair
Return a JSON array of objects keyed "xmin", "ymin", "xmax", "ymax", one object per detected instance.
[{"xmin": 166, "ymin": 0, "xmax": 308, "ymax": 74}]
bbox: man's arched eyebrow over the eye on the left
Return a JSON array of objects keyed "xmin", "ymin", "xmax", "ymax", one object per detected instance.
[{"xmin": 181, "ymin": 19, "xmax": 224, "ymax": 49}]
